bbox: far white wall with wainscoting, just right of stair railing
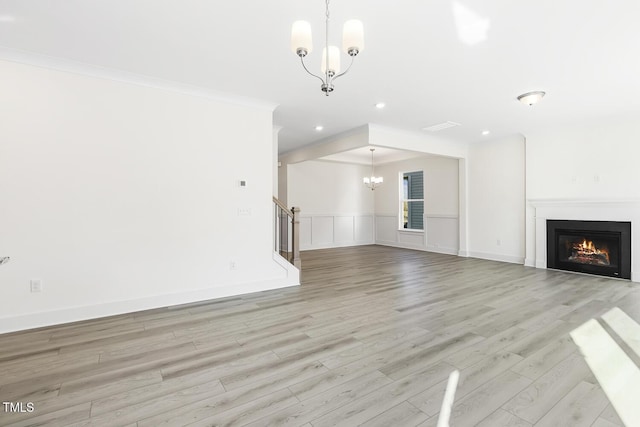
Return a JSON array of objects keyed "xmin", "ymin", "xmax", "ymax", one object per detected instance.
[{"xmin": 287, "ymin": 161, "xmax": 374, "ymax": 250}]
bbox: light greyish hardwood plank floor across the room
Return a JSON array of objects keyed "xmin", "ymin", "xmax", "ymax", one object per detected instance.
[{"xmin": 0, "ymin": 246, "xmax": 640, "ymax": 427}]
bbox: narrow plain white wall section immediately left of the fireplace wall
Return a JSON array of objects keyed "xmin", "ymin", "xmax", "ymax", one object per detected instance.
[{"xmin": 467, "ymin": 136, "xmax": 525, "ymax": 263}]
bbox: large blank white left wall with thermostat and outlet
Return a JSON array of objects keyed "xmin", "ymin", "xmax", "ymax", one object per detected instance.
[{"xmin": 0, "ymin": 61, "xmax": 291, "ymax": 332}]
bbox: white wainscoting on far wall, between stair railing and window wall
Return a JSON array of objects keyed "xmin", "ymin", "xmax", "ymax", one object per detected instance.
[{"xmin": 300, "ymin": 214, "xmax": 375, "ymax": 251}]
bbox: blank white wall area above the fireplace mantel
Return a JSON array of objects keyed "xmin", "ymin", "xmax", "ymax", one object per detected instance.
[{"xmin": 527, "ymin": 117, "xmax": 640, "ymax": 199}]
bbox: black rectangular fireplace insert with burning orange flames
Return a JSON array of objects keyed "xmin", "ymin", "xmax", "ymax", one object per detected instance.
[{"xmin": 547, "ymin": 220, "xmax": 631, "ymax": 279}]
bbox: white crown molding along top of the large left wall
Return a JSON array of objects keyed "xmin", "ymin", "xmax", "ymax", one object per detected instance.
[{"xmin": 0, "ymin": 46, "xmax": 278, "ymax": 112}]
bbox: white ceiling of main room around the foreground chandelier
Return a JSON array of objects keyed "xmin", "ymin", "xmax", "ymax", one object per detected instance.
[{"xmin": 0, "ymin": 0, "xmax": 640, "ymax": 152}]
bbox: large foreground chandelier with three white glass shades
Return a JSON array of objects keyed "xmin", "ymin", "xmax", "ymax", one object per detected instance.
[{"xmin": 291, "ymin": 0, "xmax": 364, "ymax": 96}]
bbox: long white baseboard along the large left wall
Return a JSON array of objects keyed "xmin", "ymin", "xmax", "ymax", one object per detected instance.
[{"xmin": 0, "ymin": 272, "xmax": 300, "ymax": 334}]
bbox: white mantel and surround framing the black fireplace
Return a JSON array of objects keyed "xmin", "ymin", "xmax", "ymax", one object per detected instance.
[{"xmin": 526, "ymin": 199, "xmax": 640, "ymax": 282}]
